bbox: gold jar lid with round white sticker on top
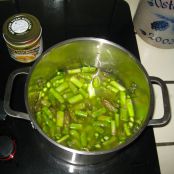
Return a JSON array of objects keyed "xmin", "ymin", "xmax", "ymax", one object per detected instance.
[{"xmin": 3, "ymin": 13, "xmax": 42, "ymax": 47}]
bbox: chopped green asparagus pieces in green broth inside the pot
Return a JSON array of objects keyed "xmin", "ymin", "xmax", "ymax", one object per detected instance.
[{"xmin": 29, "ymin": 67, "xmax": 140, "ymax": 151}]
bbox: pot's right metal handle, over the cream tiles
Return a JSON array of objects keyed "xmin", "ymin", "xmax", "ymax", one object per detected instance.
[{"xmin": 148, "ymin": 76, "xmax": 171, "ymax": 127}]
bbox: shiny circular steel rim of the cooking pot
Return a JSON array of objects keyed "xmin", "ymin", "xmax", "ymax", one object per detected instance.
[{"xmin": 24, "ymin": 37, "xmax": 154, "ymax": 155}]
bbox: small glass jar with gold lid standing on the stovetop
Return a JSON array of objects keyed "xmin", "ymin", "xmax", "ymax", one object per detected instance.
[{"xmin": 3, "ymin": 13, "xmax": 43, "ymax": 63}]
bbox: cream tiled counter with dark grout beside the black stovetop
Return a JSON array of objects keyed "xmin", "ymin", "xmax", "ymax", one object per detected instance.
[{"xmin": 126, "ymin": 0, "xmax": 174, "ymax": 174}]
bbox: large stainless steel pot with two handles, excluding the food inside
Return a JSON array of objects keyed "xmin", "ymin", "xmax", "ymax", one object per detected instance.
[{"xmin": 4, "ymin": 38, "xmax": 170, "ymax": 164}]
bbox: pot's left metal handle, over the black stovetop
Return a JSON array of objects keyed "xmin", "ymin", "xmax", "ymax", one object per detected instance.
[{"xmin": 4, "ymin": 68, "xmax": 30, "ymax": 120}]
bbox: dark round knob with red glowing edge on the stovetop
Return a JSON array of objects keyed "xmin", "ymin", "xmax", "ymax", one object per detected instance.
[{"xmin": 0, "ymin": 136, "xmax": 16, "ymax": 160}]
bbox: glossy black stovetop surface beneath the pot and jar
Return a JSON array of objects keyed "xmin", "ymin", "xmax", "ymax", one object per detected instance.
[{"xmin": 0, "ymin": 0, "xmax": 160, "ymax": 174}]
